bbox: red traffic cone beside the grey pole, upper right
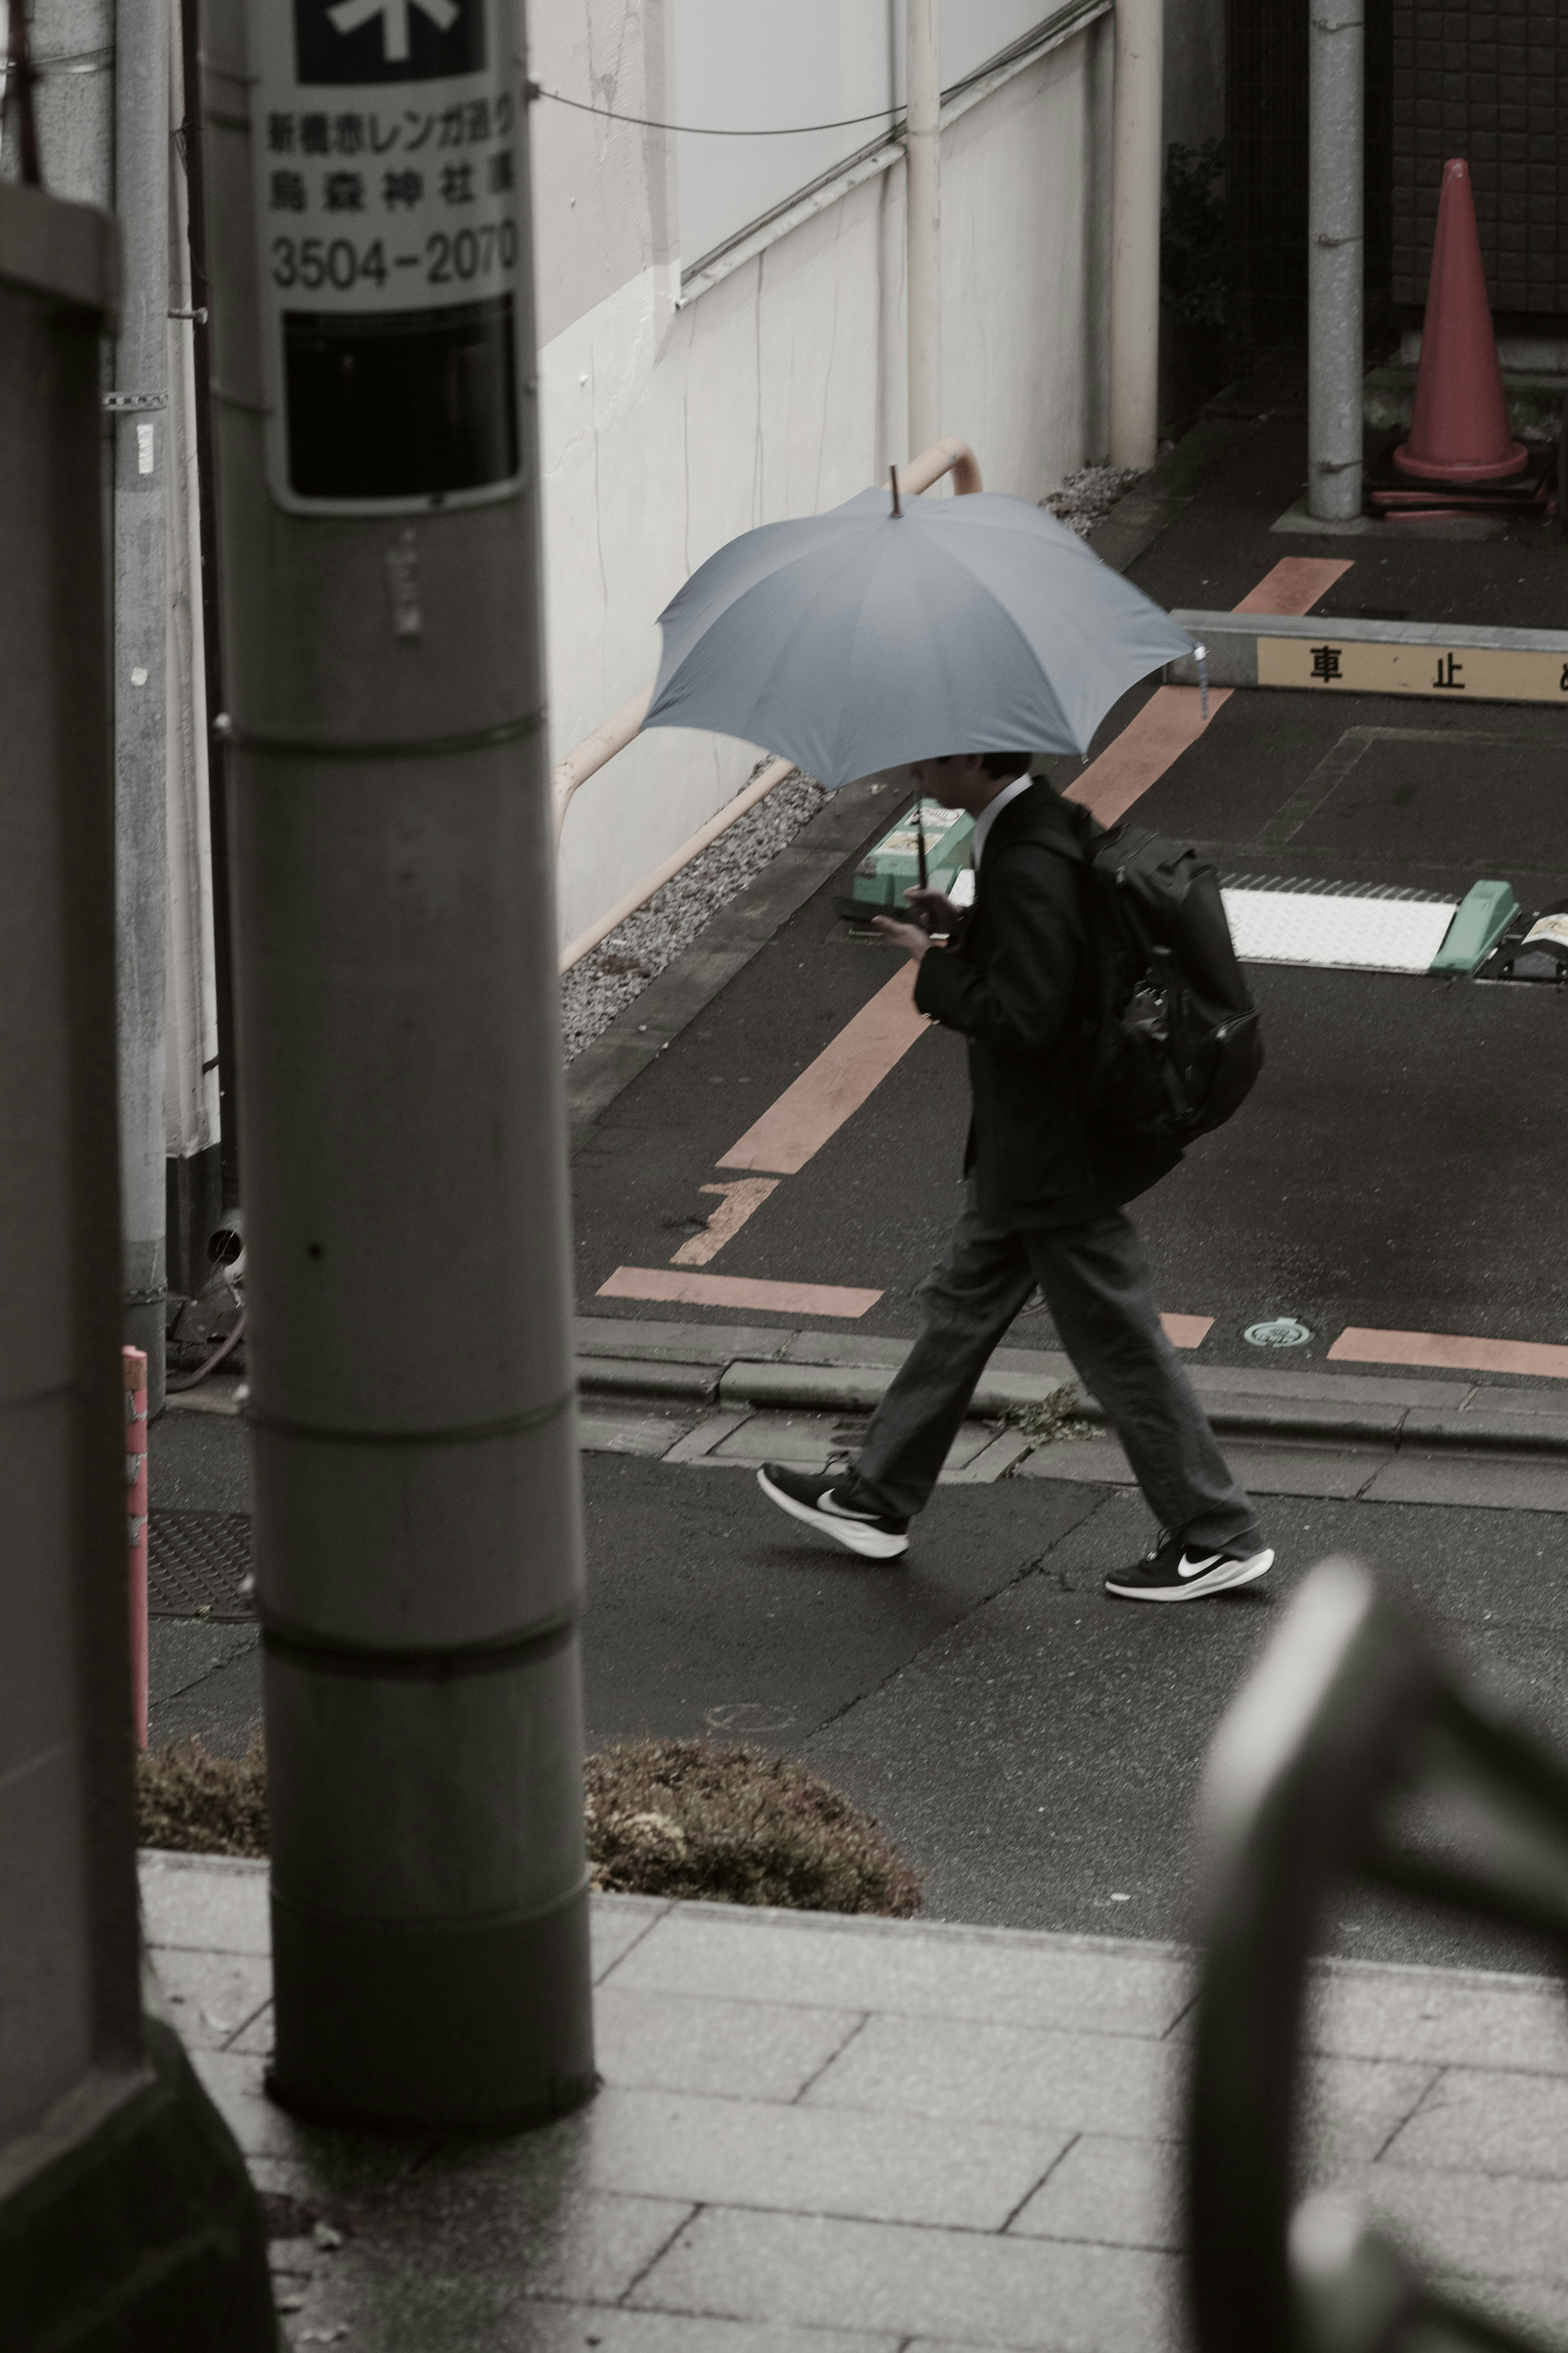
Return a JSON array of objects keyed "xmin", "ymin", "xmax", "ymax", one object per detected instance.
[{"xmin": 1394, "ymin": 163, "xmax": 1530, "ymax": 482}]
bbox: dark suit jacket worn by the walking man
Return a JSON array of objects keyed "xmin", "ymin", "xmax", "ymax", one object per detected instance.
[{"xmin": 915, "ymin": 781, "xmax": 1180, "ymax": 1231}]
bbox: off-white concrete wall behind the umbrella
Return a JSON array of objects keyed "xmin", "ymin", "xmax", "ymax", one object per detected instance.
[{"xmin": 529, "ymin": 0, "xmax": 1109, "ymax": 941}]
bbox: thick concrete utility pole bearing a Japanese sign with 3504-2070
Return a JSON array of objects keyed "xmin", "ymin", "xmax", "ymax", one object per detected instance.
[{"xmin": 202, "ymin": 0, "xmax": 595, "ymax": 2127}]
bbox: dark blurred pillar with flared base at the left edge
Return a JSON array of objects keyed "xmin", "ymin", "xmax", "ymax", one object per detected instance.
[{"xmin": 0, "ymin": 170, "xmax": 277, "ymax": 2353}]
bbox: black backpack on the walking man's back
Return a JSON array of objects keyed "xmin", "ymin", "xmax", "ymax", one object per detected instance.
[{"xmin": 1065, "ymin": 803, "xmax": 1263, "ymax": 1148}]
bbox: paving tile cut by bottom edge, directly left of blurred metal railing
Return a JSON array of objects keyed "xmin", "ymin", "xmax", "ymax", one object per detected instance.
[{"xmin": 628, "ymin": 2207, "xmax": 1180, "ymax": 2353}]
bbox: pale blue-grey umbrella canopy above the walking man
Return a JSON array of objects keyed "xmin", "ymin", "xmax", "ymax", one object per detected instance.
[{"xmin": 644, "ymin": 489, "xmax": 1192, "ymax": 786}]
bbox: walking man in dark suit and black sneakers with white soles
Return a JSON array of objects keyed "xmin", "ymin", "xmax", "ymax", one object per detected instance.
[{"xmin": 757, "ymin": 753, "xmax": 1274, "ymax": 1602}]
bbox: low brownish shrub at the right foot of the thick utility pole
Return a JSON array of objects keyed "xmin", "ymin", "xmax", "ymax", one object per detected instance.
[{"xmin": 586, "ymin": 1741, "xmax": 924, "ymax": 1920}]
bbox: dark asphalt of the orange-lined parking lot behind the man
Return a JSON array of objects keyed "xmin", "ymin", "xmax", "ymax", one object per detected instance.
[{"xmin": 574, "ymin": 421, "xmax": 1568, "ymax": 1363}]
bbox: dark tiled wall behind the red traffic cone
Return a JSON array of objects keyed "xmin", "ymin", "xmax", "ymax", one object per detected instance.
[{"xmin": 1392, "ymin": 0, "xmax": 1568, "ymax": 320}]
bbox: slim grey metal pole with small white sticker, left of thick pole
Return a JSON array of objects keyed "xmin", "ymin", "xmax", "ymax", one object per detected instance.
[{"xmin": 108, "ymin": 0, "xmax": 169, "ymax": 1414}]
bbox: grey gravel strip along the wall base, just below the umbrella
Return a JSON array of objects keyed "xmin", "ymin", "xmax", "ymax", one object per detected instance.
[{"xmin": 562, "ymin": 758, "xmax": 828, "ymax": 1061}]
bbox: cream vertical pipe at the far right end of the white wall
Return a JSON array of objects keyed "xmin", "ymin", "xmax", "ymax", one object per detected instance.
[{"xmin": 1109, "ymin": 0, "xmax": 1164, "ymax": 466}]
